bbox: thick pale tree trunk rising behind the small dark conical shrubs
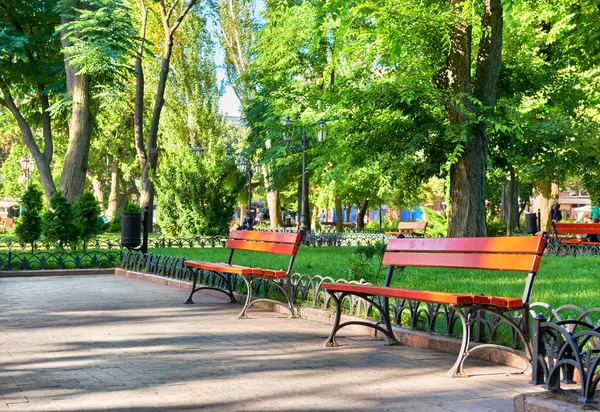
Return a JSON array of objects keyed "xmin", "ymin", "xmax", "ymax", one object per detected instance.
[{"xmin": 60, "ymin": 1, "xmax": 92, "ymax": 203}]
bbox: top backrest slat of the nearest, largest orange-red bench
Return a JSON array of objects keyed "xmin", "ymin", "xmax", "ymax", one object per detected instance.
[{"xmin": 387, "ymin": 236, "xmax": 545, "ymax": 254}]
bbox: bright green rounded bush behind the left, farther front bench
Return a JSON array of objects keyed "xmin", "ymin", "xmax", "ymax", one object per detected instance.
[{"xmin": 153, "ymin": 150, "xmax": 244, "ymax": 236}]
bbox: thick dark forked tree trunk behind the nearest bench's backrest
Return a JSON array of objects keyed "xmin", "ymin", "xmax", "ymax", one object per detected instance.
[{"xmin": 440, "ymin": 0, "xmax": 502, "ymax": 237}]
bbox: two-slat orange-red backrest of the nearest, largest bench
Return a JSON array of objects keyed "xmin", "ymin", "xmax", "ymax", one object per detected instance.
[{"xmin": 382, "ymin": 236, "xmax": 546, "ymax": 303}]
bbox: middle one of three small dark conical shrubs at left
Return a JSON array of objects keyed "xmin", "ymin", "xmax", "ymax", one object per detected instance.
[{"xmin": 42, "ymin": 192, "xmax": 78, "ymax": 249}]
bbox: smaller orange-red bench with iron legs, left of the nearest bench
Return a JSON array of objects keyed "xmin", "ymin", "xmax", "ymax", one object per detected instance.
[{"xmin": 184, "ymin": 230, "xmax": 302, "ymax": 318}]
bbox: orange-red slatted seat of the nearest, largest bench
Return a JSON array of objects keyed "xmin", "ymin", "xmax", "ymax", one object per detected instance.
[{"xmin": 322, "ymin": 283, "xmax": 523, "ymax": 309}]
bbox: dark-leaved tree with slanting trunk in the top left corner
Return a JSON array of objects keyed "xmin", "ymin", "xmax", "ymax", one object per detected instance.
[{"xmin": 0, "ymin": 0, "xmax": 63, "ymax": 201}]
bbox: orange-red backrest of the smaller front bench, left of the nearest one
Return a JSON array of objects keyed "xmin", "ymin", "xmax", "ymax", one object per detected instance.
[{"xmin": 226, "ymin": 230, "xmax": 302, "ymax": 274}]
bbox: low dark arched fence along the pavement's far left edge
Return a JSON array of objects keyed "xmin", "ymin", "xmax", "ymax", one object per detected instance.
[{"xmin": 0, "ymin": 250, "xmax": 122, "ymax": 271}]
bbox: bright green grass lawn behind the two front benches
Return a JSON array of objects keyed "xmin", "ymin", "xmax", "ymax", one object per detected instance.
[{"xmin": 150, "ymin": 247, "xmax": 600, "ymax": 308}]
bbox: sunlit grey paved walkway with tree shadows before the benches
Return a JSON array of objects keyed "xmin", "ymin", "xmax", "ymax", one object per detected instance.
[{"xmin": 0, "ymin": 276, "xmax": 536, "ymax": 412}]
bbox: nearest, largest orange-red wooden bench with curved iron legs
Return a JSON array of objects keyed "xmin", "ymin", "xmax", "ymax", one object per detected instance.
[{"xmin": 322, "ymin": 236, "xmax": 546, "ymax": 377}]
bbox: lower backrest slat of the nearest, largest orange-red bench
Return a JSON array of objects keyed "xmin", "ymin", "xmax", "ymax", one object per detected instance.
[{"xmin": 382, "ymin": 251, "xmax": 540, "ymax": 272}]
